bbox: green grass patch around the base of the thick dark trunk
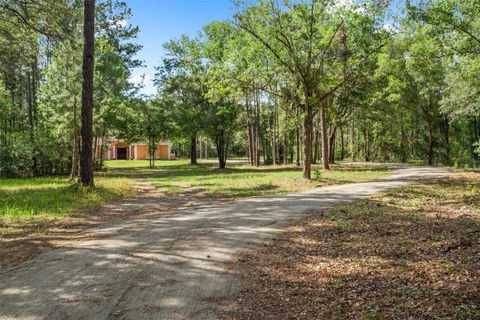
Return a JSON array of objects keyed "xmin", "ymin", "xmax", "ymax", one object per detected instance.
[{"xmin": 0, "ymin": 177, "xmax": 134, "ymax": 230}]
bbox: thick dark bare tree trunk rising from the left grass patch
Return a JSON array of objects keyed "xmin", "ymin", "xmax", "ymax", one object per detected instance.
[{"xmin": 80, "ymin": 0, "xmax": 95, "ymax": 187}]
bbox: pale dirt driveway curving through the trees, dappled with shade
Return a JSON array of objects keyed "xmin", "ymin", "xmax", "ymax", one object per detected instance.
[{"xmin": 0, "ymin": 167, "xmax": 448, "ymax": 320}]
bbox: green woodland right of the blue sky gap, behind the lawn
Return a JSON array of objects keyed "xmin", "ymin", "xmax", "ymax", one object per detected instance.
[{"xmin": 157, "ymin": 0, "xmax": 480, "ymax": 178}]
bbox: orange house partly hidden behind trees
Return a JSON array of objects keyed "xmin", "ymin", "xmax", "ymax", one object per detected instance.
[{"xmin": 96, "ymin": 139, "xmax": 175, "ymax": 160}]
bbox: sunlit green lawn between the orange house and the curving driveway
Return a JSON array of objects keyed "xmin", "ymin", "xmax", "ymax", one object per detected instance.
[{"xmin": 106, "ymin": 160, "xmax": 389, "ymax": 197}]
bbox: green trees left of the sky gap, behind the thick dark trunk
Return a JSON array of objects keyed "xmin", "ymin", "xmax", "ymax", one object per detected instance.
[{"xmin": 0, "ymin": 0, "xmax": 141, "ymax": 177}]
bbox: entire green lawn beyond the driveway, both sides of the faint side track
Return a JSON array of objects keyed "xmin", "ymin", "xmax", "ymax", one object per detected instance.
[{"xmin": 0, "ymin": 160, "xmax": 388, "ymax": 236}]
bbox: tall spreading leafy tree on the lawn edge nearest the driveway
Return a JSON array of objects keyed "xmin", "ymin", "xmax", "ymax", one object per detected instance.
[{"xmin": 236, "ymin": 0, "xmax": 390, "ymax": 179}]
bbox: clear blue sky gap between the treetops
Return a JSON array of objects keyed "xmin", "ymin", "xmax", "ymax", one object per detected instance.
[{"xmin": 126, "ymin": 0, "xmax": 234, "ymax": 94}]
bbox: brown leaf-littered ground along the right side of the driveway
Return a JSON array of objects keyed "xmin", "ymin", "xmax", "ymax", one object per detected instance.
[{"xmin": 224, "ymin": 173, "xmax": 480, "ymax": 319}]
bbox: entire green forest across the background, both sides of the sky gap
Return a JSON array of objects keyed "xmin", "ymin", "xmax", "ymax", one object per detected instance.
[{"xmin": 0, "ymin": 0, "xmax": 480, "ymax": 180}]
